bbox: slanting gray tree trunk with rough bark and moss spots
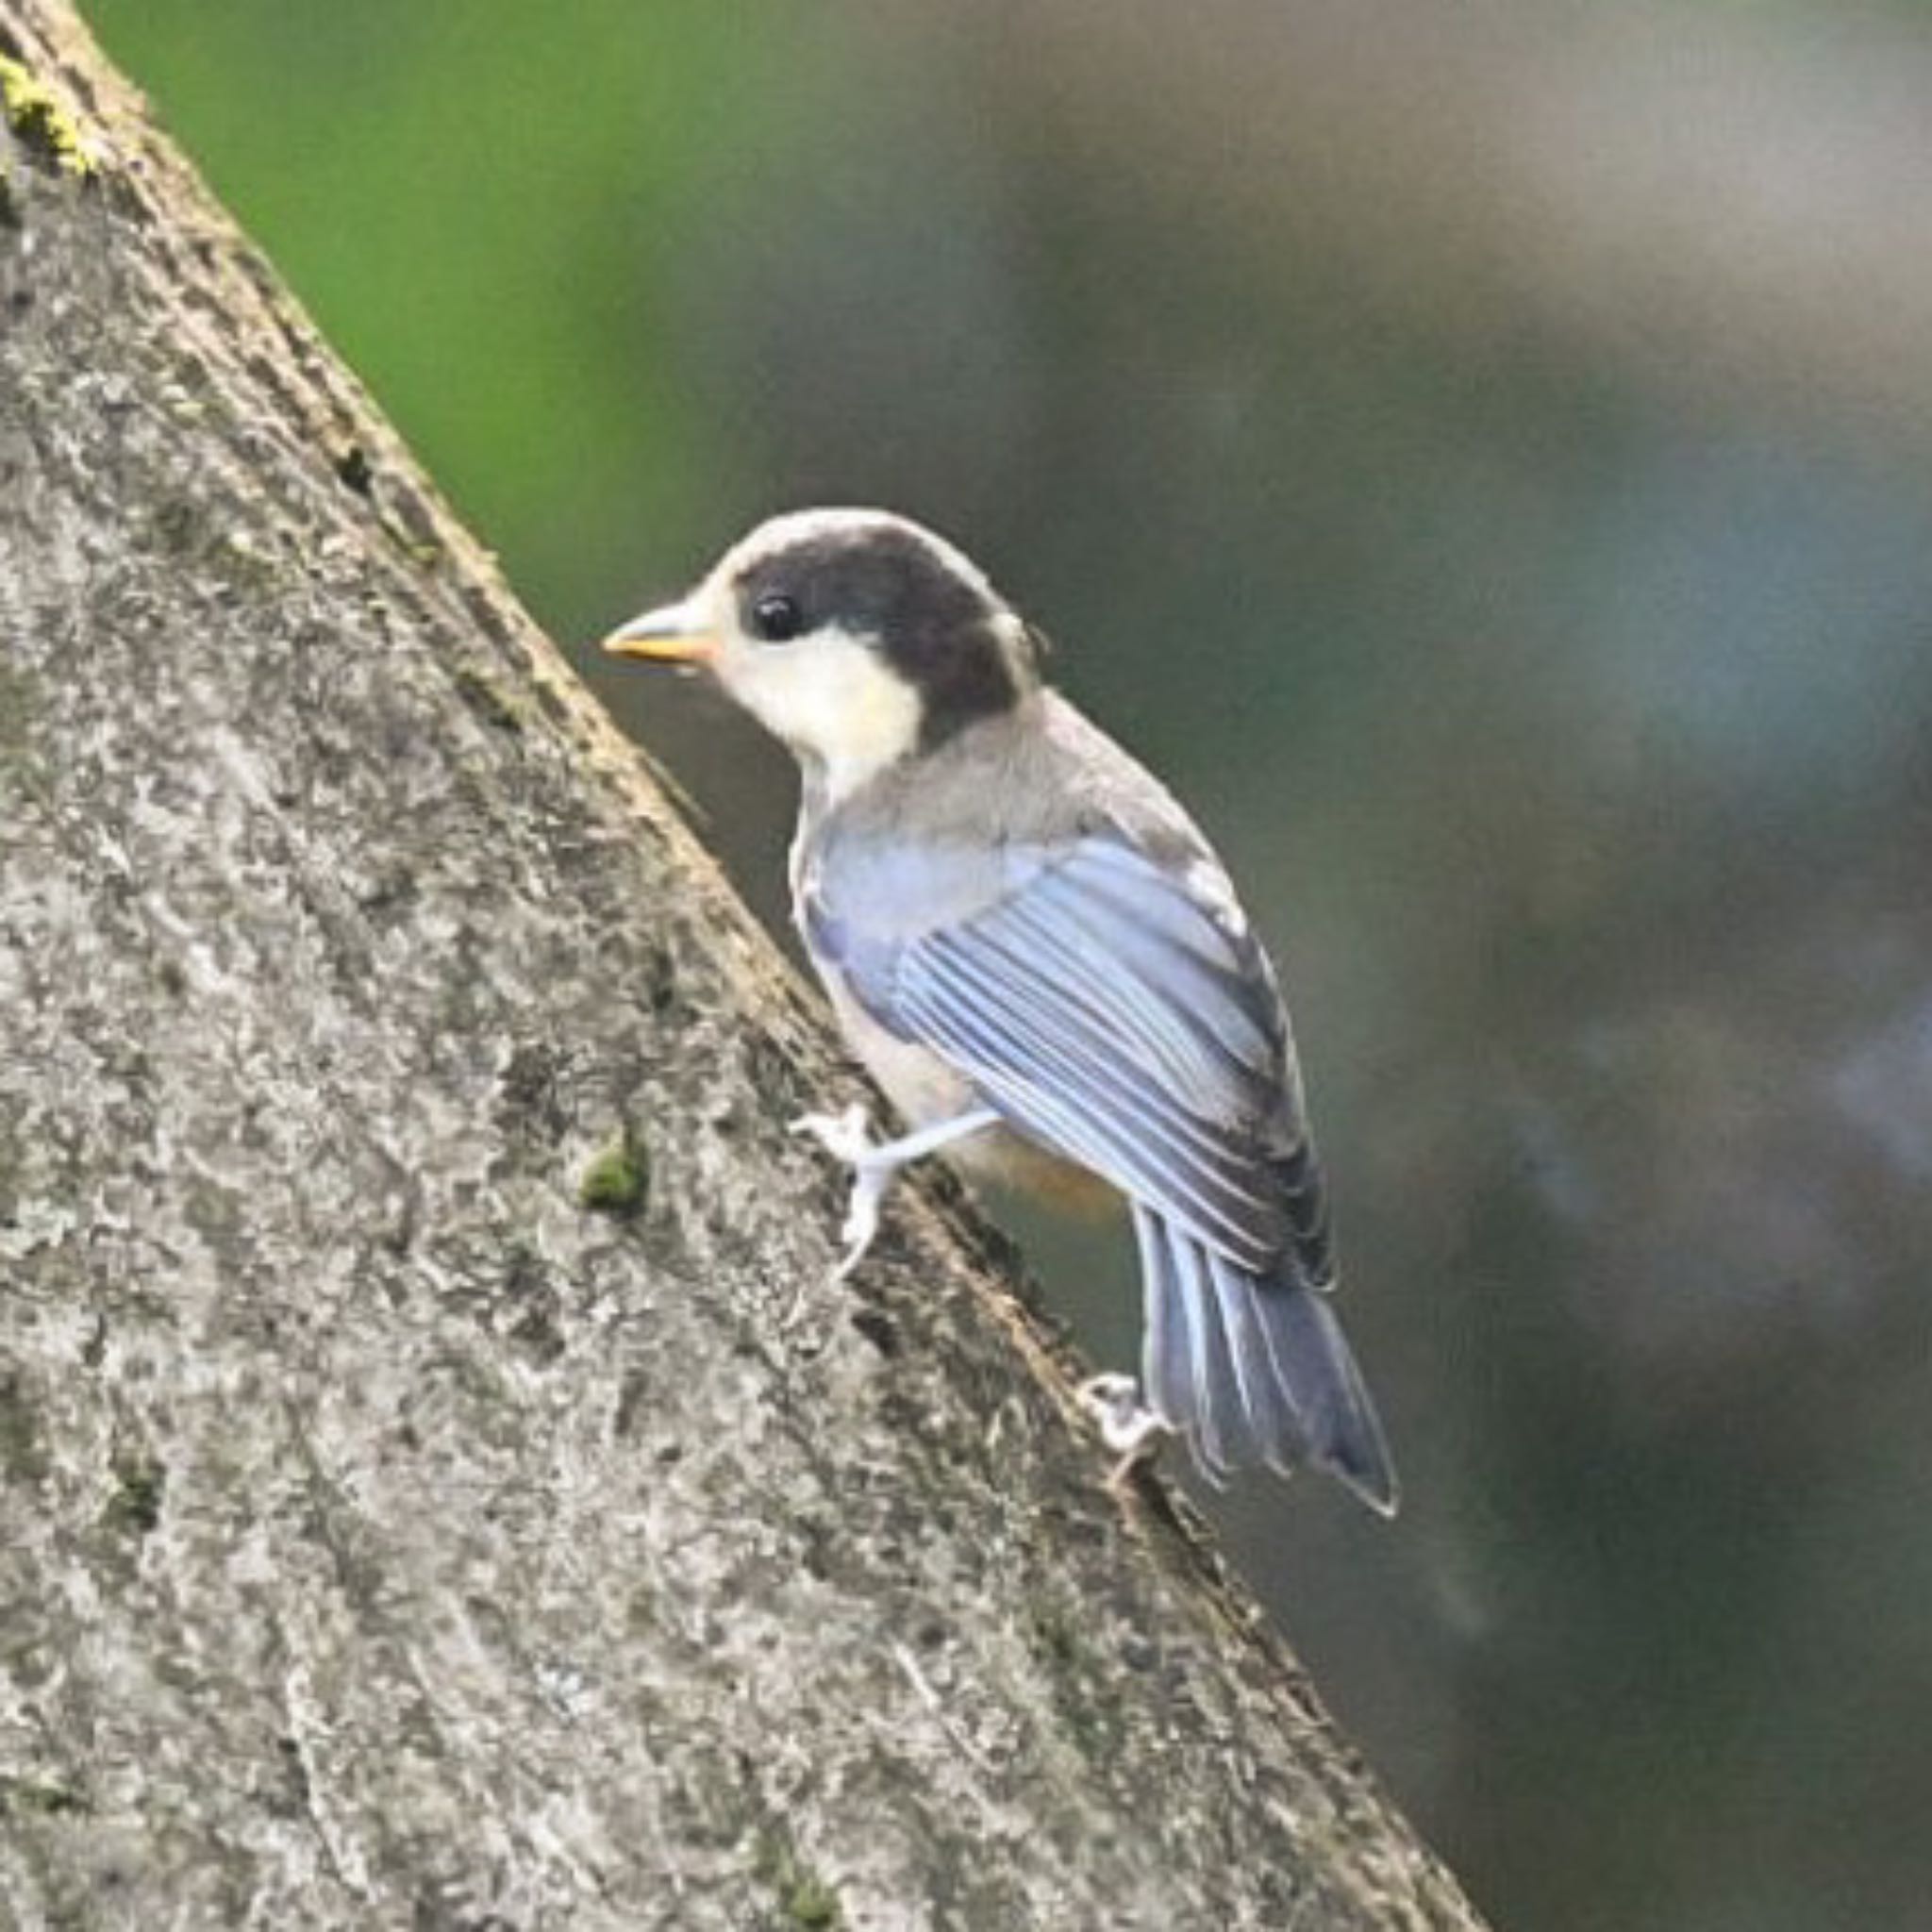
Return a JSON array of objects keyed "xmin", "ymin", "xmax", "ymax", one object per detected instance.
[{"xmin": 0, "ymin": 0, "xmax": 1476, "ymax": 1932}]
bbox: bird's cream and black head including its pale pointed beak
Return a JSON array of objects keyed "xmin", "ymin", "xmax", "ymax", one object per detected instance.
[{"xmin": 605, "ymin": 510, "xmax": 1040, "ymax": 796}]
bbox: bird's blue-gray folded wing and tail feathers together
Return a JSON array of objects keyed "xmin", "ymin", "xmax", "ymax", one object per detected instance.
[{"xmin": 813, "ymin": 837, "xmax": 1393, "ymax": 1505}]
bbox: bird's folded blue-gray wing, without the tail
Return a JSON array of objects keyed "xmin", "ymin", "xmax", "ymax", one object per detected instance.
[{"xmin": 823, "ymin": 835, "xmax": 1331, "ymax": 1285}]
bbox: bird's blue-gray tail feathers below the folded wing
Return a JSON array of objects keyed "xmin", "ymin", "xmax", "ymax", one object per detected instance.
[{"xmin": 1134, "ymin": 1204, "xmax": 1395, "ymax": 1515}]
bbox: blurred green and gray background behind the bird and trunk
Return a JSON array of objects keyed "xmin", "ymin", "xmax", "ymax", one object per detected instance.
[{"xmin": 89, "ymin": 0, "xmax": 1932, "ymax": 1932}]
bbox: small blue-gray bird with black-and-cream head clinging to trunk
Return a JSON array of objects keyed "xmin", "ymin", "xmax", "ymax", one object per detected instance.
[{"xmin": 605, "ymin": 510, "xmax": 1395, "ymax": 1511}]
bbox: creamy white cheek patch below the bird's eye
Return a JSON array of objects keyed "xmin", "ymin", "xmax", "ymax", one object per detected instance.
[{"xmin": 717, "ymin": 630, "xmax": 922, "ymax": 800}]
